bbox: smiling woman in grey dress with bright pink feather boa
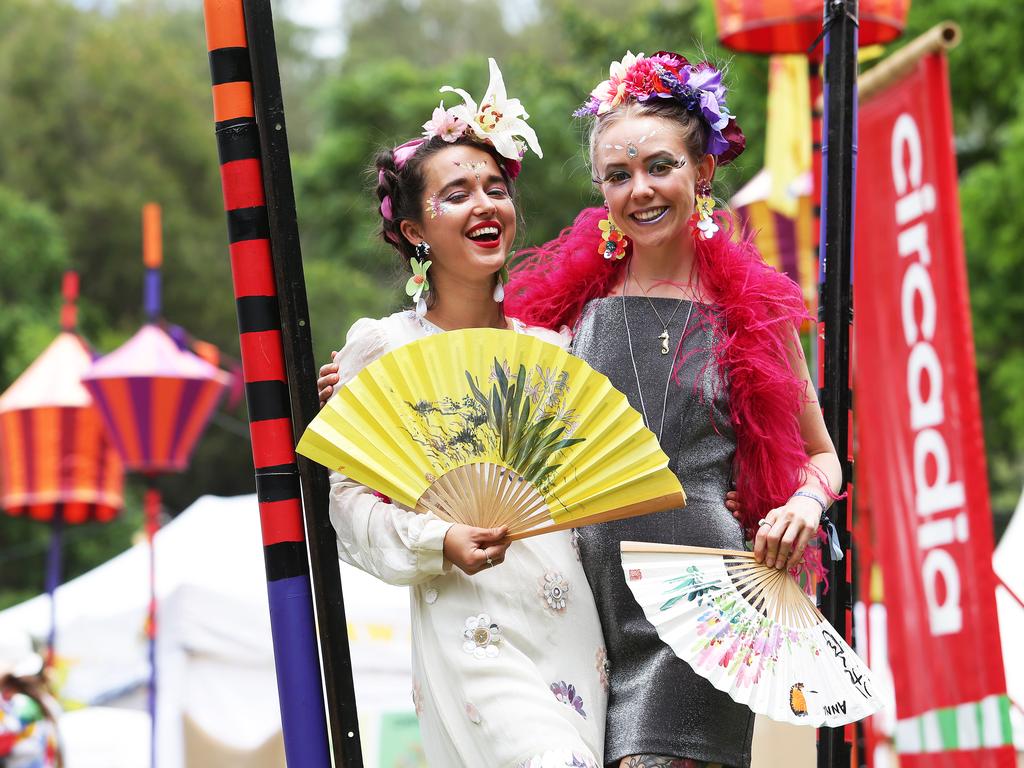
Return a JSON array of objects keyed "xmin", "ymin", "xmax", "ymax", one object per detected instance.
[{"xmin": 506, "ymin": 52, "xmax": 842, "ymax": 768}]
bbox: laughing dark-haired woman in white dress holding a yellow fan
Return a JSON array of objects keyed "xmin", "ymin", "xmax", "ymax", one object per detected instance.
[{"xmin": 301, "ymin": 60, "xmax": 622, "ymax": 768}]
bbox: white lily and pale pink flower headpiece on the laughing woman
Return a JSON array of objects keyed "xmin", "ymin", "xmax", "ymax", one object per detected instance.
[{"xmin": 423, "ymin": 58, "xmax": 544, "ymax": 178}]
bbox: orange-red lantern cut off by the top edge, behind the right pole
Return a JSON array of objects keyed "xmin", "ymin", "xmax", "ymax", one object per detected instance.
[{"xmin": 715, "ymin": 0, "xmax": 910, "ymax": 55}]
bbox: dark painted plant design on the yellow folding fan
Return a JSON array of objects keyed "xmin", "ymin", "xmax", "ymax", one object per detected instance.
[{"xmin": 407, "ymin": 357, "xmax": 585, "ymax": 489}]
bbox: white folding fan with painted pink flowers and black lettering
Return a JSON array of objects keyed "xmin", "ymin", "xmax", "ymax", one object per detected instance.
[{"xmin": 620, "ymin": 542, "xmax": 882, "ymax": 728}]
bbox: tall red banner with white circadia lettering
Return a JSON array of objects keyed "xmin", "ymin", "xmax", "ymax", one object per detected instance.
[{"xmin": 854, "ymin": 54, "xmax": 1015, "ymax": 768}]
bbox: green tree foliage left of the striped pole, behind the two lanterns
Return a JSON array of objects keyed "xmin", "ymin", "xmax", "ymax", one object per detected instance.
[{"xmin": 0, "ymin": 0, "xmax": 262, "ymax": 604}]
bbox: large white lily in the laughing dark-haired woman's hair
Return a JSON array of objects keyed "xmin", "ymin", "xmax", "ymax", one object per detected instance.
[{"xmin": 441, "ymin": 58, "xmax": 544, "ymax": 161}]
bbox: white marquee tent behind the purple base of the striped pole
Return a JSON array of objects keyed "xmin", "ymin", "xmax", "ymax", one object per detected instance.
[{"xmin": 0, "ymin": 496, "xmax": 417, "ymax": 768}]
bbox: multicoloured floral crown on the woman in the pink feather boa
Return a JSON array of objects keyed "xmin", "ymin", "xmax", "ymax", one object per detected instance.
[{"xmin": 572, "ymin": 51, "xmax": 746, "ymax": 165}]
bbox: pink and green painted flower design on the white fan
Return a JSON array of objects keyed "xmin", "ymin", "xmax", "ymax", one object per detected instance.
[{"xmin": 660, "ymin": 565, "xmax": 818, "ymax": 686}]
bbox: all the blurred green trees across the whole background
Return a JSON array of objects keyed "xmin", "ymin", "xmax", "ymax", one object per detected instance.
[{"xmin": 0, "ymin": 0, "xmax": 1024, "ymax": 607}]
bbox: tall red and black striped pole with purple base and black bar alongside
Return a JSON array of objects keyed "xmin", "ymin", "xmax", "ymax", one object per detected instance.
[{"xmin": 204, "ymin": 0, "xmax": 362, "ymax": 768}]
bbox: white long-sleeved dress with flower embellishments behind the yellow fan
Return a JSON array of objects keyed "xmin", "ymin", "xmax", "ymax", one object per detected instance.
[{"xmin": 331, "ymin": 311, "xmax": 617, "ymax": 768}]
